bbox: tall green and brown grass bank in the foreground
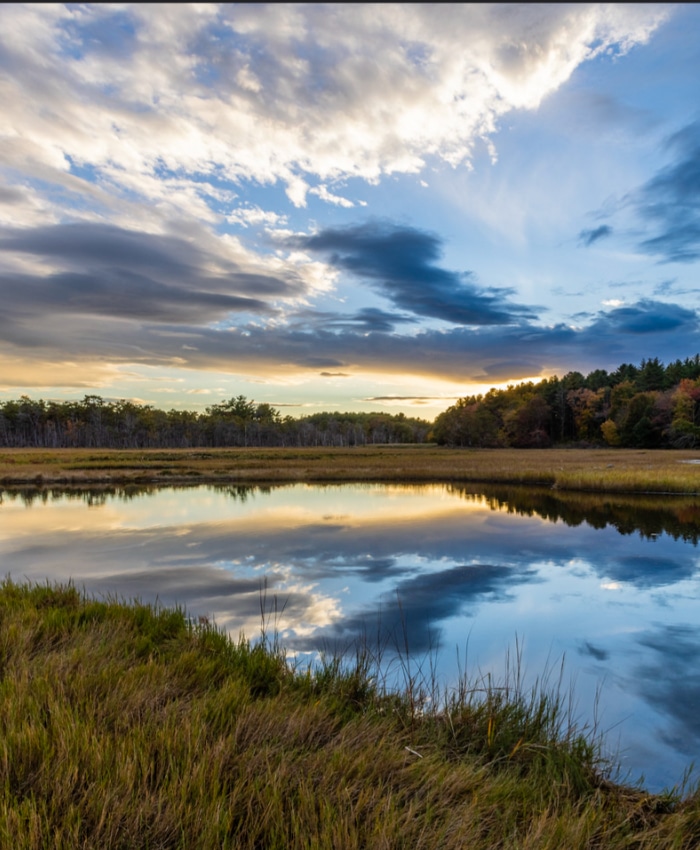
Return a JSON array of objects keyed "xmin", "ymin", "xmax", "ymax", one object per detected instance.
[{"xmin": 0, "ymin": 582, "xmax": 700, "ymax": 850}]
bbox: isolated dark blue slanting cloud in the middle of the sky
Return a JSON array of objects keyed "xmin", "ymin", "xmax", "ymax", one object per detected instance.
[{"xmin": 289, "ymin": 222, "xmax": 535, "ymax": 325}]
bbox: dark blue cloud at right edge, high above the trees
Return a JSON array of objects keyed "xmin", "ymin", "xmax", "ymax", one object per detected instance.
[{"xmin": 632, "ymin": 121, "xmax": 700, "ymax": 262}]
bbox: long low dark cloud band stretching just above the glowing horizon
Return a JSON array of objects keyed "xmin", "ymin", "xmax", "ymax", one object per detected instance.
[{"xmin": 0, "ymin": 288, "xmax": 700, "ymax": 383}]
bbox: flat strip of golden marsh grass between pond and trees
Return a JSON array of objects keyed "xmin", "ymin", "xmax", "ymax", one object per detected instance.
[{"xmin": 0, "ymin": 445, "xmax": 700, "ymax": 494}]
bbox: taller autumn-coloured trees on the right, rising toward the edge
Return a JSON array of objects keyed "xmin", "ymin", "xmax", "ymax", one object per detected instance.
[{"xmin": 431, "ymin": 354, "xmax": 700, "ymax": 448}]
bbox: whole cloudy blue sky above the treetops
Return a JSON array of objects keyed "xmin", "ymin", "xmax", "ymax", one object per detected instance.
[{"xmin": 0, "ymin": 3, "xmax": 700, "ymax": 419}]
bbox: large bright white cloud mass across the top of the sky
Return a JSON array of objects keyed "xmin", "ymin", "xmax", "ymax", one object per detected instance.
[{"xmin": 0, "ymin": 4, "xmax": 668, "ymax": 224}]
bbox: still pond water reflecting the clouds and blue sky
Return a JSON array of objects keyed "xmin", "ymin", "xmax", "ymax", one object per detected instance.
[{"xmin": 0, "ymin": 484, "xmax": 700, "ymax": 790}]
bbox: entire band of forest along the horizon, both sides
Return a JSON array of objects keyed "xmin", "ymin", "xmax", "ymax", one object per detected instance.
[{"xmin": 0, "ymin": 354, "xmax": 700, "ymax": 449}]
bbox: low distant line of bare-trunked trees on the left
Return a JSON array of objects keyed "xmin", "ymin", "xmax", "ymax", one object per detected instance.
[{"xmin": 0, "ymin": 395, "xmax": 430, "ymax": 449}]
